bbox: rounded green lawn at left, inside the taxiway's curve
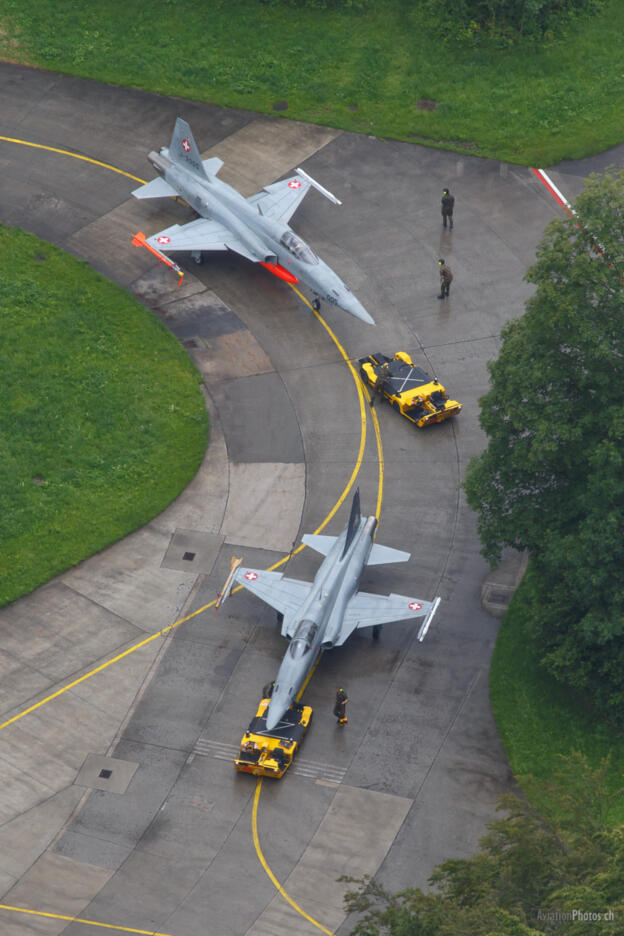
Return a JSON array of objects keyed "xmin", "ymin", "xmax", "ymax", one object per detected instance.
[{"xmin": 0, "ymin": 227, "xmax": 208, "ymax": 605}]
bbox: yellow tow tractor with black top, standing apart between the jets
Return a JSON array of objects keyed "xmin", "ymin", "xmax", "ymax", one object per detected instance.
[{"xmin": 359, "ymin": 351, "xmax": 462, "ymax": 428}]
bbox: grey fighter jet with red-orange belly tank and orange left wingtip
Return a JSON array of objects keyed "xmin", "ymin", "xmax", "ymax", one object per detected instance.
[{"xmin": 132, "ymin": 117, "xmax": 375, "ymax": 325}]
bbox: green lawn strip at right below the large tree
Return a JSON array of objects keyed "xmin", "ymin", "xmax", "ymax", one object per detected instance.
[{"xmin": 490, "ymin": 584, "xmax": 624, "ymax": 822}]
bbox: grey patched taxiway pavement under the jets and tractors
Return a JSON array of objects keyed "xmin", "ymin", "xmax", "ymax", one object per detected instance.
[{"xmin": 0, "ymin": 64, "xmax": 604, "ymax": 936}]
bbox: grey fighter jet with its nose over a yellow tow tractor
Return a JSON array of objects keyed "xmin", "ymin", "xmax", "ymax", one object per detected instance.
[{"xmin": 220, "ymin": 491, "xmax": 440, "ymax": 731}]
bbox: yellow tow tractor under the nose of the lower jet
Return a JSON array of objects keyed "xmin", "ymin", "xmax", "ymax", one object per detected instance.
[{"xmin": 234, "ymin": 699, "xmax": 312, "ymax": 779}]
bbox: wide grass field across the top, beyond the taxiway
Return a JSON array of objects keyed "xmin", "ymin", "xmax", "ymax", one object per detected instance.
[{"xmin": 0, "ymin": 0, "xmax": 624, "ymax": 166}]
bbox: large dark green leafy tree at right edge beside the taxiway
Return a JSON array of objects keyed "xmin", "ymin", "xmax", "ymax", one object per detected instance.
[{"xmin": 465, "ymin": 170, "xmax": 624, "ymax": 717}]
